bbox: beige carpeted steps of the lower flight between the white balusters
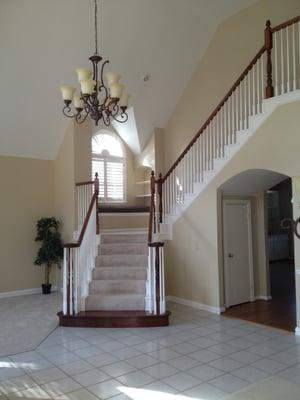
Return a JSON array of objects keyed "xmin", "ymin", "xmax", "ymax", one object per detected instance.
[{"xmin": 85, "ymin": 233, "xmax": 148, "ymax": 311}]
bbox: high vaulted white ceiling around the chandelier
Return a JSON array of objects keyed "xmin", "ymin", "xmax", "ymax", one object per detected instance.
[{"xmin": 0, "ymin": 0, "xmax": 256, "ymax": 159}]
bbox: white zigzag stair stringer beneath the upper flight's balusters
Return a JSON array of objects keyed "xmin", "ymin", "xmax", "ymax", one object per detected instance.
[{"xmin": 154, "ymin": 90, "xmax": 300, "ymax": 241}]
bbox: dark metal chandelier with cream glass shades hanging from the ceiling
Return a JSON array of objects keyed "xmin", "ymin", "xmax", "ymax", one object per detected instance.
[{"xmin": 60, "ymin": 0, "xmax": 129, "ymax": 126}]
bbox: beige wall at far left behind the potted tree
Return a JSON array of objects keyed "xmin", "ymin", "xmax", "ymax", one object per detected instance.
[{"xmin": 0, "ymin": 156, "xmax": 56, "ymax": 293}]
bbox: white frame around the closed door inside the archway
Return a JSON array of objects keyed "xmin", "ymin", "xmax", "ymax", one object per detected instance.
[{"xmin": 222, "ymin": 199, "xmax": 255, "ymax": 308}]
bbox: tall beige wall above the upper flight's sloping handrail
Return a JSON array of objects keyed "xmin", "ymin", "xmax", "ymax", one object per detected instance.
[{"xmin": 164, "ymin": 0, "xmax": 300, "ymax": 170}]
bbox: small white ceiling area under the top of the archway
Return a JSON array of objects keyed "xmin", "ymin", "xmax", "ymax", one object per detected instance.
[{"xmin": 220, "ymin": 169, "xmax": 288, "ymax": 196}]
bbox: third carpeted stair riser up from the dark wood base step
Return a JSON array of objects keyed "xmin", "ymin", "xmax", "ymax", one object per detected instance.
[{"xmin": 93, "ymin": 267, "xmax": 147, "ymax": 280}]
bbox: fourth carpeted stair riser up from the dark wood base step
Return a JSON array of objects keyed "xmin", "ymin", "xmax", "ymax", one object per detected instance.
[{"xmin": 96, "ymin": 254, "xmax": 148, "ymax": 267}]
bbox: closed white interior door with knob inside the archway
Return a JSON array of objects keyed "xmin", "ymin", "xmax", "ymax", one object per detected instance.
[{"xmin": 223, "ymin": 200, "xmax": 253, "ymax": 307}]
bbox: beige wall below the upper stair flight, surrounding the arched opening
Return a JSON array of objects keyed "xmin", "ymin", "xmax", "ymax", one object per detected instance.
[{"xmin": 166, "ymin": 102, "xmax": 300, "ymax": 307}]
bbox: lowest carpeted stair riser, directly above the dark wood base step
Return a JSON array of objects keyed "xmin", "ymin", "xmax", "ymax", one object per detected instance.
[{"xmin": 85, "ymin": 294, "xmax": 145, "ymax": 311}]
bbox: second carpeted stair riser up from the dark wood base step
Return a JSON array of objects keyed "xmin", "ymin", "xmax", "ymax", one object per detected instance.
[{"xmin": 89, "ymin": 280, "xmax": 146, "ymax": 296}]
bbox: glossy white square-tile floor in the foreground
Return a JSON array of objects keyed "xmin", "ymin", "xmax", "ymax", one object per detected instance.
[{"xmin": 0, "ymin": 303, "xmax": 300, "ymax": 400}]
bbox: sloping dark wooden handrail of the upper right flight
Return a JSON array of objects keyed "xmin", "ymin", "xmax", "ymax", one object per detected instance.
[{"xmin": 163, "ymin": 45, "xmax": 266, "ymax": 182}]
